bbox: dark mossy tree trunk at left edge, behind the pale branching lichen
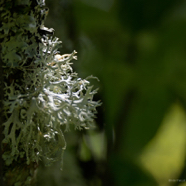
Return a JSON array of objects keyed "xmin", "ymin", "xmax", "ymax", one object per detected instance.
[{"xmin": 0, "ymin": 0, "xmax": 47, "ymax": 186}]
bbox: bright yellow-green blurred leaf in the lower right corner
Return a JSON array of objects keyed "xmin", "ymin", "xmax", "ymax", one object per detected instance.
[{"xmin": 141, "ymin": 104, "xmax": 186, "ymax": 186}]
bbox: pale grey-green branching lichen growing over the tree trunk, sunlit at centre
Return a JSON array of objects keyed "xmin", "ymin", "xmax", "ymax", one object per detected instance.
[{"xmin": 0, "ymin": 0, "xmax": 100, "ymax": 168}]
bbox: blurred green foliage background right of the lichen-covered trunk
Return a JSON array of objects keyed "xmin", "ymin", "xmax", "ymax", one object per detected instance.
[{"xmin": 38, "ymin": 0, "xmax": 186, "ymax": 186}]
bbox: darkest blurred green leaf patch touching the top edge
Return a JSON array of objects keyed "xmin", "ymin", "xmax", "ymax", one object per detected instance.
[{"xmin": 119, "ymin": 0, "xmax": 181, "ymax": 32}]
